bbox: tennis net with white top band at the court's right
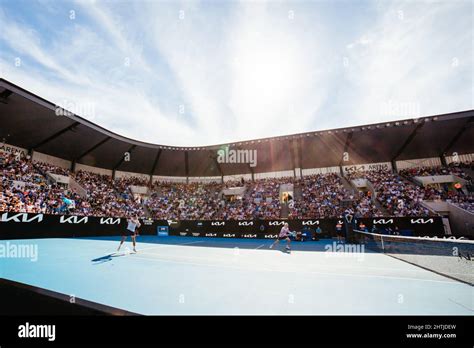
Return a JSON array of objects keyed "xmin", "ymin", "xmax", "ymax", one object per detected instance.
[{"xmin": 354, "ymin": 231, "xmax": 474, "ymax": 285}]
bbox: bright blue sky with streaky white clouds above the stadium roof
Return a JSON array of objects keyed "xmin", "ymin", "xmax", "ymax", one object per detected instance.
[{"xmin": 0, "ymin": 0, "xmax": 474, "ymax": 146}]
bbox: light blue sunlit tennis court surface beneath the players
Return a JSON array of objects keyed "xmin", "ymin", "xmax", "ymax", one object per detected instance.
[{"xmin": 0, "ymin": 236, "xmax": 474, "ymax": 315}]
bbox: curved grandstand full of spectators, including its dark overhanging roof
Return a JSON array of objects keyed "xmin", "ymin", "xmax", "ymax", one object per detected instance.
[{"xmin": 0, "ymin": 80, "xmax": 474, "ymax": 235}]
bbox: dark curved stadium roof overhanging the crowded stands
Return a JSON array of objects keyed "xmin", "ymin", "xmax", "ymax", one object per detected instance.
[{"xmin": 0, "ymin": 79, "xmax": 474, "ymax": 177}]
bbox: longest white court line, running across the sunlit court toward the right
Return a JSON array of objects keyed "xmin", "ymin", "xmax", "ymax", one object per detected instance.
[{"xmin": 127, "ymin": 254, "xmax": 467, "ymax": 285}]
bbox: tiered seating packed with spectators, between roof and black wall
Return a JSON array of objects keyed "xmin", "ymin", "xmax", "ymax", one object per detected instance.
[{"xmin": 0, "ymin": 153, "xmax": 474, "ymax": 220}]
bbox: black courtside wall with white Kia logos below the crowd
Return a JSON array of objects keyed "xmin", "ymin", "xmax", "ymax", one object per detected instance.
[{"xmin": 0, "ymin": 213, "xmax": 445, "ymax": 239}]
